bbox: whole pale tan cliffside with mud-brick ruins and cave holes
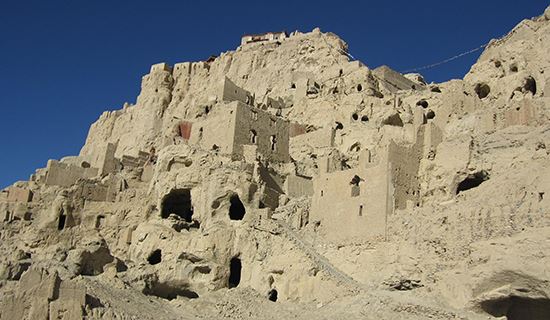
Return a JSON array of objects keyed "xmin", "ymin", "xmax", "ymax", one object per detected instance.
[{"xmin": 0, "ymin": 8, "xmax": 550, "ymax": 320}]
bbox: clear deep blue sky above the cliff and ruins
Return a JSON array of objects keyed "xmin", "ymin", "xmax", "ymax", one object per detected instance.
[{"xmin": 0, "ymin": 0, "xmax": 549, "ymax": 188}]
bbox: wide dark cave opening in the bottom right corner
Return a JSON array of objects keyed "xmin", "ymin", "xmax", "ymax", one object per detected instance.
[{"xmin": 481, "ymin": 296, "xmax": 550, "ymax": 320}]
